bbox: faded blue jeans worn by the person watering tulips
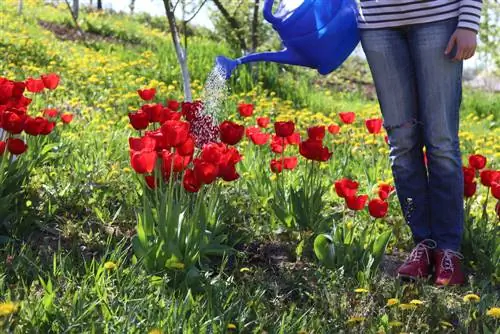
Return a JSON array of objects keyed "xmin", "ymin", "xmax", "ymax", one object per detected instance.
[{"xmin": 361, "ymin": 18, "xmax": 464, "ymax": 251}]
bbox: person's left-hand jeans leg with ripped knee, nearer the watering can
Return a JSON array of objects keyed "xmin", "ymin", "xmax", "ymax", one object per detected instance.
[{"xmin": 361, "ymin": 29, "xmax": 431, "ymax": 243}]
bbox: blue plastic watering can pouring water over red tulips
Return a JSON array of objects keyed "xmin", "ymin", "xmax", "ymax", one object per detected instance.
[{"xmin": 216, "ymin": 0, "xmax": 359, "ymax": 79}]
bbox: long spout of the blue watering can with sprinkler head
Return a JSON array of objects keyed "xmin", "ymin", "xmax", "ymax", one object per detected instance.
[{"xmin": 215, "ymin": 49, "xmax": 307, "ymax": 79}]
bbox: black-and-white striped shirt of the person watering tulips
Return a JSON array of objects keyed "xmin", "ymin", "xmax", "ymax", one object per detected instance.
[{"xmin": 358, "ymin": 0, "xmax": 483, "ymax": 32}]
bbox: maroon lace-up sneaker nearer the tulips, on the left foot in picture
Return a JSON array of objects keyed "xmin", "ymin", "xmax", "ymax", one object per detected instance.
[{"xmin": 398, "ymin": 239, "xmax": 436, "ymax": 279}]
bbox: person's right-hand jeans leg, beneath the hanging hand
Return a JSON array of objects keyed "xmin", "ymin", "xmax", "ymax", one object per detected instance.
[{"xmin": 408, "ymin": 19, "xmax": 464, "ymax": 251}]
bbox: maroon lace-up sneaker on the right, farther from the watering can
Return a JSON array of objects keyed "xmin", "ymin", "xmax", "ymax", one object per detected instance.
[{"xmin": 434, "ymin": 249, "xmax": 465, "ymax": 286}]
